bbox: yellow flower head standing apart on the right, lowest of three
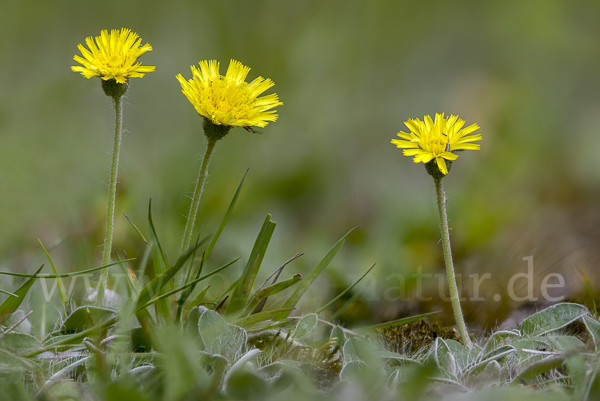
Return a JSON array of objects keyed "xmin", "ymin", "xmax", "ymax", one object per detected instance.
[{"xmin": 392, "ymin": 113, "xmax": 481, "ymax": 175}]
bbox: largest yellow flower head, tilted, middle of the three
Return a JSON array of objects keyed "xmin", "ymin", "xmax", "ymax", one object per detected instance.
[{"xmin": 177, "ymin": 60, "xmax": 283, "ymax": 127}]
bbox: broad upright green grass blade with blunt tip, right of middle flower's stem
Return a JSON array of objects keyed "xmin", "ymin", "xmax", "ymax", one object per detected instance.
[{"xmin": 227, "ymin": 214, "xmax": 276, "ymax": 314}]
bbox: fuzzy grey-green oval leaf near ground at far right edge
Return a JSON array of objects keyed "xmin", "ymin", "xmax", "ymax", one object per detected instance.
[{"xmin": 518, "ymin": 303, "xmax": 590, "ymax": 336}]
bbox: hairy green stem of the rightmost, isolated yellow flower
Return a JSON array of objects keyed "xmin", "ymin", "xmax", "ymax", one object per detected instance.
[{"xmin": 433, "ymin": 178, "xmax": 472, "ymax": 348}]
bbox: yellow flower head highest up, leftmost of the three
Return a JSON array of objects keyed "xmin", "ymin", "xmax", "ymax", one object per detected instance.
[{"xmin": 71, "ymin": 28, "xmax": 156, "ymax": 84}]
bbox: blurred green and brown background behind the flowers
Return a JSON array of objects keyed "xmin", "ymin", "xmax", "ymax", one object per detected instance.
[{"xmin": 0, "ymin": 0, "xmax": 600, "ymax": 328}]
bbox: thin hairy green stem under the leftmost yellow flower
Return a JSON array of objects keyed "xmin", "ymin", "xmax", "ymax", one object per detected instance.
[{"xmin": 96, "ymin": 95, "xmax": 123, "ymax": 305}]
